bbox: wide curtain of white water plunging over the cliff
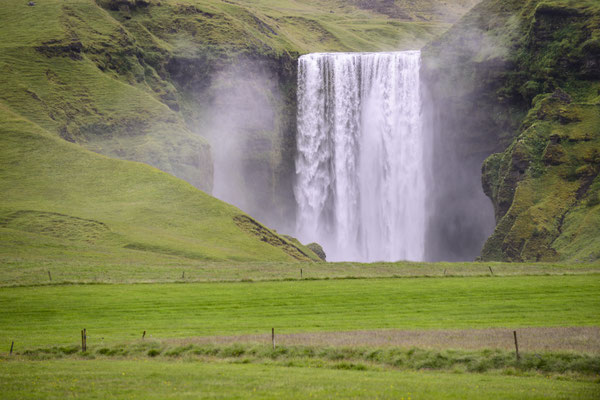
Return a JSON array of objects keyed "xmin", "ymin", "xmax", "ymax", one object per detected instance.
[{"xmin": 294, "ymin": 51, "xmax": 425, "ymax": 261}]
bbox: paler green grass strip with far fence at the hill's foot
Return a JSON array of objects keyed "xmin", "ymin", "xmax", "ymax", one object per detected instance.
[{"xmin": 0, "ymin": 256, "xmax": 600, "ymax": 286}]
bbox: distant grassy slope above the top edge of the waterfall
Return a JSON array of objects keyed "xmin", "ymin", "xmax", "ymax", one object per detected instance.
[{"xmin": 124, "ymin": 0, "xmax": 473, "ymax": 54}]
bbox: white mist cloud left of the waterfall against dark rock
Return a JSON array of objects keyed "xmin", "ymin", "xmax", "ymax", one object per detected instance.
[{"xmin": 197, "ymin": 60, "xmax": 295, "ymax": 231}]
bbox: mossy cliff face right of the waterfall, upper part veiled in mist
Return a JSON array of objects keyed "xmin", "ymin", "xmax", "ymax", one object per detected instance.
[{"xmin": 424, "ymin": 0, "xmax": 600, "ymax": 261}]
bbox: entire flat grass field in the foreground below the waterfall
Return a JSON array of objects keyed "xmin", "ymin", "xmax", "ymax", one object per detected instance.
[{"xmin": 0, "ymin": 263, "xmax": 600, "ymax": 400}]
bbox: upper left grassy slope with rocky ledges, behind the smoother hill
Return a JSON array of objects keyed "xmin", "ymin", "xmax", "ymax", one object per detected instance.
[{"xmin": 0, "ymin": 0, "xmax": 212, "ymax": 190}]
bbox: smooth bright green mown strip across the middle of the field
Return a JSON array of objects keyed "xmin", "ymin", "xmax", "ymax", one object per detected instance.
[{"xmin": 0, "ymin": 275, "xmax": 600, "ymax": 349}]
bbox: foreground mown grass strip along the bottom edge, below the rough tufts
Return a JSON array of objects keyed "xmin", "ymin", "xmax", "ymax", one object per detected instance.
[{"xmin": 0, "ymin": 360, "xmax": 598, "ymax": 400}]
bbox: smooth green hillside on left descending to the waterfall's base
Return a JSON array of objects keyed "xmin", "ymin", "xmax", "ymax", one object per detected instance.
[{"xmin": 0, "ymin": 106, "xmax": 318, "ymax": 263}]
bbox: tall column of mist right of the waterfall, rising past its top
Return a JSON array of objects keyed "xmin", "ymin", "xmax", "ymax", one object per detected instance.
[{"xmin": 421, "ymin": 10, "xmax": 516, "ymax": 261}]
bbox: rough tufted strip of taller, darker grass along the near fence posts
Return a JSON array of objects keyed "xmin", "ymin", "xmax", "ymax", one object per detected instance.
[{"xmin": 15, "ymin": 340, "xmax": 600, "ymax": 379}]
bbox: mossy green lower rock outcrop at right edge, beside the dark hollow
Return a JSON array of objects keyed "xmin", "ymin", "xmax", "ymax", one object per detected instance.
[{"xmin": 483, "ymin": 92, "xmax": 600, "ymax": 261}]
